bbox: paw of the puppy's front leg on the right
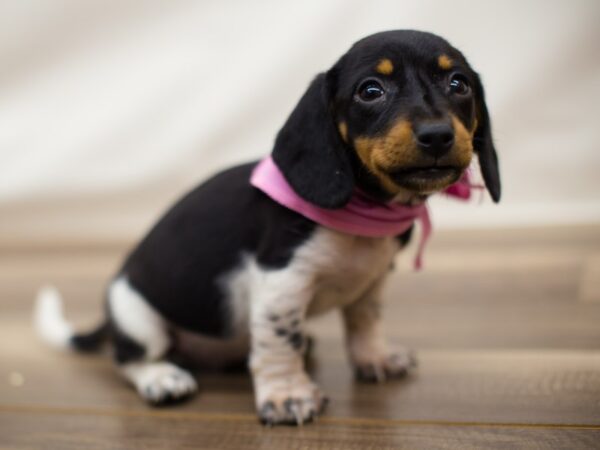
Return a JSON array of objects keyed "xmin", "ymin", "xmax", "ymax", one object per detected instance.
[{"xmin": 354, "ymin": 350, "xmax": 417, "ymax": 383}]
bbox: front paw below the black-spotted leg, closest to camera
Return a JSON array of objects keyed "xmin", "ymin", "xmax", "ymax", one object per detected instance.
[{"xmin": 257, "ymin": 381, "xmax": 328, "ymax": 426}]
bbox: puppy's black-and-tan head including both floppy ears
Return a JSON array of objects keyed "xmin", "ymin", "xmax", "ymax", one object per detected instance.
[{"xmin": 273, "ymin": 30, "xmax": 500, "ymax": 208}]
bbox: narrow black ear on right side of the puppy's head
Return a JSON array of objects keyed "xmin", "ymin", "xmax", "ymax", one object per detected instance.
[{"xmin": 473, "ymin": 76, "xmax": 501, "ymax": 203}]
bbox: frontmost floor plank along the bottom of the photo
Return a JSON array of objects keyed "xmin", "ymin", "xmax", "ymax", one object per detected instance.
[{"xmin": 0, "ymin": 409, "xmax": 600, "ymax": 450}]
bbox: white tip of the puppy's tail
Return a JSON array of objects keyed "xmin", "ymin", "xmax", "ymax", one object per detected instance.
[{"xmin": 33, "ymin": 286, "xmax": 74, "ymax": 349}]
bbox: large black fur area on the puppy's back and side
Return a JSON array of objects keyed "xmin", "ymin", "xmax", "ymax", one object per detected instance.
[{"xmin": 122, "ymin": 163, "xmax": 315, "ymax": 337}]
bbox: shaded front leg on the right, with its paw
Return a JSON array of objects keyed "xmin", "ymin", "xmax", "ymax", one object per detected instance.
[{"xmin": 343, "ymin": 278, "xmax": 416, "ymax": 382}]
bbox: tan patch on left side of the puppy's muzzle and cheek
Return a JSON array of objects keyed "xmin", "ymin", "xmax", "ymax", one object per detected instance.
[{"xmin": 354, "ymin": 120, "xmax": 418, "ymax": 193}]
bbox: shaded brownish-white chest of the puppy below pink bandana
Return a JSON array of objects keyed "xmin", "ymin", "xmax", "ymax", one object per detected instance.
[{"xmin": 308, "ymin": 230, "xmax": 399, "ymax": 316}]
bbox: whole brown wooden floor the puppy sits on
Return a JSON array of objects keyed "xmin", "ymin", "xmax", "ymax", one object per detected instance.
[{"xmin": 0, "ymin": 226, "xmax": 600, "ymax": 450}]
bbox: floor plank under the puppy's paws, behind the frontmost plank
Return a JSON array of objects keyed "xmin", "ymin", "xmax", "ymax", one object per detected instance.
[{"xmin": 0, "ymin": 325, "xmax": 600, "ymax": 425}]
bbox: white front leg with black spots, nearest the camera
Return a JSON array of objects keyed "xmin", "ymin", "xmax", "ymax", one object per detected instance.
[{"xmin": 250, "ymin": 273, "xmax": 326, "ymax": 425}]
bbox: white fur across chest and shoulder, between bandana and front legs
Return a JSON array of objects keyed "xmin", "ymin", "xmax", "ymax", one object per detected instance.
[{"xmin": 221, "ymin": 227, "xmax": 399, "ymax": 334}]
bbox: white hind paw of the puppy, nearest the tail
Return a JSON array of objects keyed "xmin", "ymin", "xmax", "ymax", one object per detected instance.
[{"xmin": 124, "ymin": 362, "xmax": 198, "ymax": 405}]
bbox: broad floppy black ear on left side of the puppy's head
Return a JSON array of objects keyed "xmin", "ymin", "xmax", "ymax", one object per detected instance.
[{"xmin": 272, "ymin": 72, "xmax": 354, "ymax": 209}]
